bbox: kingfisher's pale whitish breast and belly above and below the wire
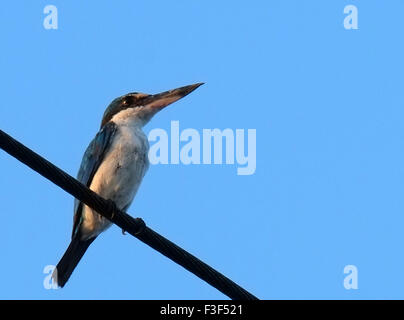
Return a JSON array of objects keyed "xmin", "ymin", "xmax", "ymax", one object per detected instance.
[{"xmin": 81, "ymin": 124, "xmax": 149, "ymax": 239}]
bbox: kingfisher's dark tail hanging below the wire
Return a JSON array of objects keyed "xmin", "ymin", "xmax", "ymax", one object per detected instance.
[{"xmin": 52, "ymin": 236, "xmax": 95, "ymax": 288}]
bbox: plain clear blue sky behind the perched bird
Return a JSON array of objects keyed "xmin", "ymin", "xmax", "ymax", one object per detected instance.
[{"xmin": 0, "ymin": 0, "xmax": 404, "ymax": 299}]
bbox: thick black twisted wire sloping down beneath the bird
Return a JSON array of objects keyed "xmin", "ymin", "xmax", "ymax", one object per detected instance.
[{"xmin": 0, "ymin": 130, "xmax": 258, "ymax": 300}]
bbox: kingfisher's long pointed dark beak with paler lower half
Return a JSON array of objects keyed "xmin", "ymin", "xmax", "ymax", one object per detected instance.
[{"xmin": 143, "ymin": 82, "xmax": 203, "ymax": 112}]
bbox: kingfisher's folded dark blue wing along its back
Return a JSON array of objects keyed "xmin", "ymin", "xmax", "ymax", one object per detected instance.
[{"xmin": 72, "ymin": 121, "xmax": 117, "ymax": 237}]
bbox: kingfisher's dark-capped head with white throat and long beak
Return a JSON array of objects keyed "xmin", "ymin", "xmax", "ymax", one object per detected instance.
[{"xmin": 101, "ymin": 83, "xmax": 203, "ymax": 128}]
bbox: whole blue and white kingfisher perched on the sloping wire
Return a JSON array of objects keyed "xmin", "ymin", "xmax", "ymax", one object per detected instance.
[{"xmin": 52, "ymin": 83, "xmax": 203, "ymax": 287}]
